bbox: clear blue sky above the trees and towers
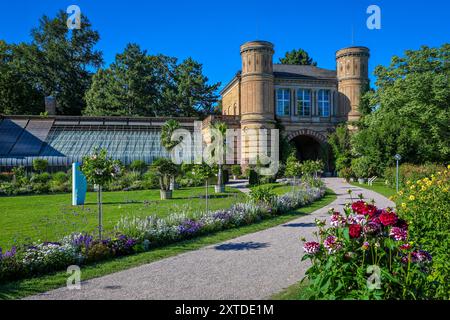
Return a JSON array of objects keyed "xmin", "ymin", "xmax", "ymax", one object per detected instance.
[{"xmin": 0, "ymin": 0, "xmax": 450, "ymax": 90}]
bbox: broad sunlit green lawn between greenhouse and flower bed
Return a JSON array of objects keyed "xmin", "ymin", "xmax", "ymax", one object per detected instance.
[{"xmin": 0, "ymin": 187, "xmax": 245, "ymax": 248}]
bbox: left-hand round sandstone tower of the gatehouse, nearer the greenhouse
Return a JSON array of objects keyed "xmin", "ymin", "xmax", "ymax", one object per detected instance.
[{"xmin": 241, "ymin": 41, "xmax": 275, "ymax": 165}]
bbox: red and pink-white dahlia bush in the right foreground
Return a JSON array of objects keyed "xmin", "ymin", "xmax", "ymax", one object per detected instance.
[{"xmin": 303, "ymin": 200, "xmax": 432, "ymax": 299}]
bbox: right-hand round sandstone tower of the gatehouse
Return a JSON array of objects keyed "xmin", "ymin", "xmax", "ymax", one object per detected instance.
[{"xmin": 336, "ymin": 47, "xmax": 370, "ymax": 121}]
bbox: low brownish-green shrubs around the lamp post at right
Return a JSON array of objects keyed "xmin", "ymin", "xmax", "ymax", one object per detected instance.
[{"xmin": 384, "ymin": 163, "xmax": 445, "ymax": 188}]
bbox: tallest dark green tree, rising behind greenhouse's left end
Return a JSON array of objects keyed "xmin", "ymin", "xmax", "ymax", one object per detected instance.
[{"xmin": 22, "ymin": 11, "xmax": 103, "ymax": 115}]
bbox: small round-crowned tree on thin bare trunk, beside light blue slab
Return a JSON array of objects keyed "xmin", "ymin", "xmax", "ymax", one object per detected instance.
[{"xmin": 80, "ymin": 149, "xmax": 122, "ymax": 240}]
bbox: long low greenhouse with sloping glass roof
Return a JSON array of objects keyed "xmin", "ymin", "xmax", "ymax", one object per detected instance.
[{"xmin": 0, "ymin": 116, "xmax": 196, "ymax": 170}]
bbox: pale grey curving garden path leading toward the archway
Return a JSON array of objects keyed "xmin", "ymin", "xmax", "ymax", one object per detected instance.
[{"xmin": 30, "ymin": 178, "xmax": 393, "ymax": 300}]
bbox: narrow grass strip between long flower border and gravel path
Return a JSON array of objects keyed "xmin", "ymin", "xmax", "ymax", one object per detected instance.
[{"xmin": 0, "ymin": 190, "xmax": 336, "ymax": 299}]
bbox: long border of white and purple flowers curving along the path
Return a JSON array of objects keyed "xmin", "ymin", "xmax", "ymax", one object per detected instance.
[{"xmin": 0, "ymin": 184, "xmax": 325, "ymax": 282}]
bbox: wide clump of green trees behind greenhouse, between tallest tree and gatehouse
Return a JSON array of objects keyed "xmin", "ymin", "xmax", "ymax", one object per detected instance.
[{"xmin": 84, "ymin": 43, "xmax": 219, "ymax": 117}]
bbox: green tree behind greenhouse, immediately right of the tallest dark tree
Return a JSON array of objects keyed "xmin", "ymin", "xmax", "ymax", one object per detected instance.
[{"xmin": 84, "ymin": 43, "xmax": 176, "ymax": 117}]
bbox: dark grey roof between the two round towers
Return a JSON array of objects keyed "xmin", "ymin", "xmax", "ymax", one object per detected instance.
[{"xmin": 273, "ymin": 64, "xmax": 336, "ymax": 80}]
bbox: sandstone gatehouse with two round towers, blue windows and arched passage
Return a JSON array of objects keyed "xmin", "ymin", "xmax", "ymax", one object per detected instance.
[{"xmin": 221, "ymin": 41, "xmax": 370, "ymax": 168}]
